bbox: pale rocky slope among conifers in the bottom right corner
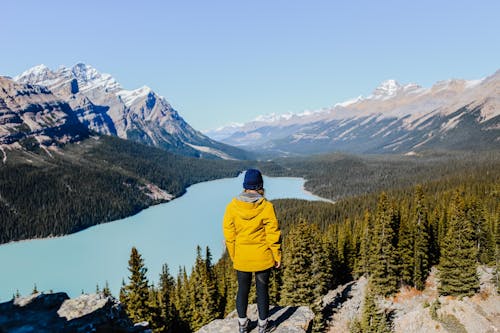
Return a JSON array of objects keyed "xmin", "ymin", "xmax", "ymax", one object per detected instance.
[{"xmin": 323, "ymin": 266, "xmax": 500, "ymax": 333}]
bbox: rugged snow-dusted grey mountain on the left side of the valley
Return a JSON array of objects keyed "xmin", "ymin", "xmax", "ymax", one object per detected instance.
[{"xmin": 0, "ymin": 63, "xmax": 248, "ymax": 159}]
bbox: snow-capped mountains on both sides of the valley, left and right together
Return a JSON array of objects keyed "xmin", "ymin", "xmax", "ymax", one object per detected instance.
[{"xmin": 0, "ymin": 63, "xmax": 500, "ymax": 159}]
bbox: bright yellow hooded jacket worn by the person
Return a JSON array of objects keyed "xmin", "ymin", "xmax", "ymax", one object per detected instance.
[{"xmin": 223, "ymin": 198, "xmax": 281, "ymax": 272}]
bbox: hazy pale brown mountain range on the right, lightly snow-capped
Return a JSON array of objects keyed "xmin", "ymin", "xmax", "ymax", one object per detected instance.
[{"xmin": 205, "ymin": 71, "xmax": 500, "ymax": 155}]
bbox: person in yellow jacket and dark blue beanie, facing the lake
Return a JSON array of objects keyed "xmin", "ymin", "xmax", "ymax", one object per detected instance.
[{"xmin": 223, "ymin": 169, "xmax": 281, "ymax": 333}]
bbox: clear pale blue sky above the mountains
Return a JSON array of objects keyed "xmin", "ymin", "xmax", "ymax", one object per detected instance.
[{"xmin": 0, "ymin": 0, "xmax": 500, "ymax": 129}]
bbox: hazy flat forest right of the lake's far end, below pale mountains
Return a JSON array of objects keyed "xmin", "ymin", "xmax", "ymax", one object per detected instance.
[{"xmin": 262, "ymin": 151, "xmax": 500, "ymax": 201}]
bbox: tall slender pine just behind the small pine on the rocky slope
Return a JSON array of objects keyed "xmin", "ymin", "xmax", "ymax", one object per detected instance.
[{"xmin": 370, "ymin": 193, "xmax": 398, "ymax": 296}]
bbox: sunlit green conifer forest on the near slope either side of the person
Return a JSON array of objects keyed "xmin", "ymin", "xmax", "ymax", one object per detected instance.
[{"xmin": 115, "ymin": 160, "xmax": 500, "ymax": 333}]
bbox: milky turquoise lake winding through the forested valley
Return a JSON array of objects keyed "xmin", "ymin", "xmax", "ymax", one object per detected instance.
[{"xmin": 0, "ymin": 175, "xmax": 321, "ymax": 302}]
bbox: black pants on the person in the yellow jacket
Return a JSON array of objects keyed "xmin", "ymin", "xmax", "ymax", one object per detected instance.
[{"xmin": 236, "ymin": 269, "xmax": 271, "ymax": 320}]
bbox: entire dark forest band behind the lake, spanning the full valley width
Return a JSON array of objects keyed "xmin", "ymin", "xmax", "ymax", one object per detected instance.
[{"xmin": 0, "ymin": 136, "xmax": 500, "ymax": 244}]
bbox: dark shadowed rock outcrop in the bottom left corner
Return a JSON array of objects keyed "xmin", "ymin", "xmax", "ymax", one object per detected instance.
[{"xmin": 0, "ymin": 293, "xmax": 148, "ymax": 333}]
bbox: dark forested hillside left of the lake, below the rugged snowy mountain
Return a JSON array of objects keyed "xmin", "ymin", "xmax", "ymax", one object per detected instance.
[{"xmin": 0, "ymin": 136, "xmax": 250, "ymax": 244}]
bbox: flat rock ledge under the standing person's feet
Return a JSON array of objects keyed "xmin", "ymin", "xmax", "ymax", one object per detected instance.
[{"xmin": 197, "ymin": 304, "xmax": 314, "ymax": 333}]
